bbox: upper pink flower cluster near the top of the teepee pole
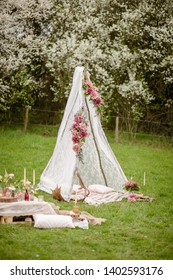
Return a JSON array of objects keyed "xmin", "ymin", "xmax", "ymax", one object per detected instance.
[{"xmin": 84, "ymin": 81, "xmax": 103, "ymax": 107}]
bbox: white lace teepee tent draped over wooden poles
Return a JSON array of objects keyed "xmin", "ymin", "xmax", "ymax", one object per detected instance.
[{"xmin": 39, "ymin": 66, "xmax": 127, "ymax": 201}]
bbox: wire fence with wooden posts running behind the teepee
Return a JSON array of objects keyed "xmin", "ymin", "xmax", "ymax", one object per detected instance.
[{"xmin": 0, "ymin": 107, "xmax": 173, "ymax": 142}]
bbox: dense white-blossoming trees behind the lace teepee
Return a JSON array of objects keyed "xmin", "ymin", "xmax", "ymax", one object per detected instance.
[{"xmin": 0, "ymin": 0, "xmax": 173, "ymax": 132}]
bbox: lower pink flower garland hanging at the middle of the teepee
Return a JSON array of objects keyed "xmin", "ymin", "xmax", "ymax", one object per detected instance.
[{"xmin": 71, "ymin": 109, "xmax": 88, "ymax": 160}]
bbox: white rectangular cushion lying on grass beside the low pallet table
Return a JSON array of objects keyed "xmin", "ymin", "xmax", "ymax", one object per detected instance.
[{"xmin": 33, "ymin": 214, "xmax": 75, "ymax": 228}]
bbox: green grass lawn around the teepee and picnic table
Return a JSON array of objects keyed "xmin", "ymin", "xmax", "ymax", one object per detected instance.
[{"xmin": 0, "ymin": 129, "xmax": 173, "ymax": 260}]
